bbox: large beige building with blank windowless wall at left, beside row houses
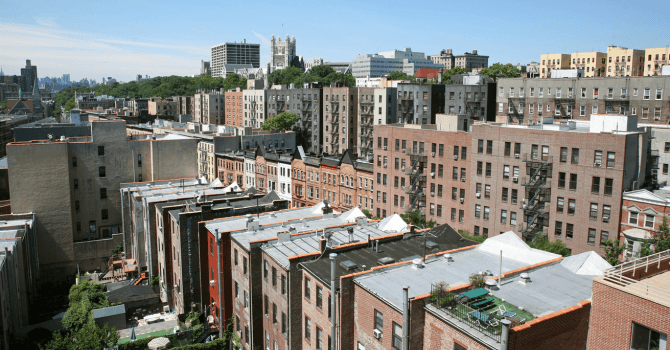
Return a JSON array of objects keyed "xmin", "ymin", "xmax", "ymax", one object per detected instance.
[{"xmin": 7, "ymin": 120, "xmax": 198, "ymax": 283}]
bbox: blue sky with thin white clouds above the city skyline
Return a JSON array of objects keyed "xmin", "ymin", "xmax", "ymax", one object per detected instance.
[{"xmin": 0, "ymin": 0, "xmax": 670, "ymax": 82}]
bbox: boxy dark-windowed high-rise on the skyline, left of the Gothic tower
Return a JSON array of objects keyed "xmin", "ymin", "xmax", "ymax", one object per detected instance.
[{"xmin": 211, "ymin": 39, "xmax": 261, "ymax": 77}]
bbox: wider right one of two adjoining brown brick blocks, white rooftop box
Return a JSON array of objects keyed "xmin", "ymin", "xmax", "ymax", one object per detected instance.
[{"xmin": 467, "ymin": 114, "xmax": 650, "ymax": 254}]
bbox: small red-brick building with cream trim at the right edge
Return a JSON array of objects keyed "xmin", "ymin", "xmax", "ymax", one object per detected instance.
[{"xmin": 620, "ymin": 186, "xmax": 670, "ymax": 259}]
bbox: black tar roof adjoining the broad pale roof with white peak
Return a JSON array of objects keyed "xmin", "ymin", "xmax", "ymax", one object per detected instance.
[{"xmin": 302, "ymin": 225, "xmax": 478, "ymax": 288}]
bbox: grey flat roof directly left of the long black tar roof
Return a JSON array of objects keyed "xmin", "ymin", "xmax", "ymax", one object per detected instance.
[{"xmin": 263, "ymin": 214, "xmax": 407, "ymax": 268}]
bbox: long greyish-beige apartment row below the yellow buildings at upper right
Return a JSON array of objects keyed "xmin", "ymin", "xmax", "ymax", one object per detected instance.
[{"xmin": 496, "ymin": 76, "xmax": 670, "ymax": 125}]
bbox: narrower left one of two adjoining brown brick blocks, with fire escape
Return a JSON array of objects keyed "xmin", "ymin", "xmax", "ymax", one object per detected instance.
[{"xmin": 374, "ymin": 124, "xmax": 474, "ymax": 230}]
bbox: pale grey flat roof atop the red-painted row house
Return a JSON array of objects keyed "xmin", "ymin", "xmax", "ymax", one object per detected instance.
[{"xmin": 205, "ymin": 202, "xmax": 336, "ymax": 242}]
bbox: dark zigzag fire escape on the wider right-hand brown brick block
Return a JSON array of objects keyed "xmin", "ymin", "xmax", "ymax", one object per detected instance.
[{"xmin": 520, "ymin": 153, "xmax": 553, "ymax": 241}]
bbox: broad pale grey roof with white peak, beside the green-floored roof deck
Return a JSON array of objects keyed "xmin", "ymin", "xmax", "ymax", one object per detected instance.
[{"xmin": 355, "ymin": 231, "xmax": 560, "ymax": 310}]
